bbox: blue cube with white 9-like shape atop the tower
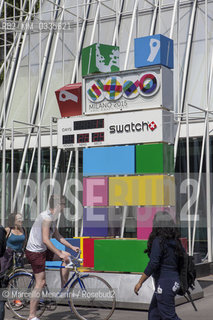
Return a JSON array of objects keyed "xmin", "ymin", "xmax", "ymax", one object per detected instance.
[{"xmin": 135, "ymin": 34, "xmax": 173, "ymax": 69}]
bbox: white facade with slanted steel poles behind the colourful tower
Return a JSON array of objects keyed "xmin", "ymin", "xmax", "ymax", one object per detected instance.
[{"xmin": 0, "ymin": 0, "xmax": 213, "ymax": 262}]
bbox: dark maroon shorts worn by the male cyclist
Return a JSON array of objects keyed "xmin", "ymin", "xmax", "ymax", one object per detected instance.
[{"xmin": 25, "ymin": 249, "xmax": 61, "ymax": 273}]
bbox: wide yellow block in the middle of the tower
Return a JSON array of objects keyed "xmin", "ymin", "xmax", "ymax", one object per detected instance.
[{"xmin": 109, "ymin": 175, "xmax": 175, "ymax": 206}]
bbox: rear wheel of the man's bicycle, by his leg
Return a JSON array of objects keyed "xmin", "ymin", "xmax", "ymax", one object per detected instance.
[{"xmin": 7, "ymin": 272, "xmax": 45, "ymax": 320}]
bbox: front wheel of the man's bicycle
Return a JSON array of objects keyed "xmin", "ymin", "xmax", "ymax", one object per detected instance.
[{"xmin": 69, "ymin": 275, "xmax": 116, "ymax": 320}]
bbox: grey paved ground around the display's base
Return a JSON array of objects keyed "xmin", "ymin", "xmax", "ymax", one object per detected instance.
[{"xmin": 5, "ymin": 276, "xmax": 213, "ymax": 320}]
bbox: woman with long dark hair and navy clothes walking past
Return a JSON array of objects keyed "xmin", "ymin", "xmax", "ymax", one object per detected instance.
[{"xmin": 134, "ymin": 211, "xmax": 184, "ymax": 320}]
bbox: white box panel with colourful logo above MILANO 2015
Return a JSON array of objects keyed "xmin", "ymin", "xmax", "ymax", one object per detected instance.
[{"xmin": 82, "ymin": 66, "xmax": 173, "ymax": 114}]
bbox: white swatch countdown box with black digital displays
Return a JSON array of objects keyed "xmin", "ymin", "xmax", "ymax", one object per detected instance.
[{"xmin": 58, "ymin": 109, "xmax": 174, "ymax": 149}]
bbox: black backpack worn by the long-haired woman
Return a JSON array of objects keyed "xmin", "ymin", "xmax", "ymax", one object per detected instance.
[{"xmin": 178, "ymin": 250, "xmax": 197, "ymax": 311}]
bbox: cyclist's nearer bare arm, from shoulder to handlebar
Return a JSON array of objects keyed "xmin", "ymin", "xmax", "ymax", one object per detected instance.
[{"xmin": 42, "ymin": 220, "xmax": 69, "ymax": 263}]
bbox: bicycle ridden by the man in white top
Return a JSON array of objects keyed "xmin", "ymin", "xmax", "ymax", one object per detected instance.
[{"xmin": 7, "ymin": 252, "xmax": 116, "ymax": 320}]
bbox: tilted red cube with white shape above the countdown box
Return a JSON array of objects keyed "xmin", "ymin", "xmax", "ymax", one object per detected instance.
[{"xmin": 55, "ymin": 83, "xmax": 82, "ymax": 117}]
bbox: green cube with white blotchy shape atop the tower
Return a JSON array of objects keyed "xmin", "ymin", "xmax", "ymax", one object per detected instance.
[{"xmin": 82, "ymin": 43, "xmax": 119, "ymax": 76}]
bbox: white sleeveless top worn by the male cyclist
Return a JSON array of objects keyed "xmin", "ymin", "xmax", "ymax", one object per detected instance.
[{"xmin": 26, "ymin": 210, "xmax": 56, "ymax": 252}]
